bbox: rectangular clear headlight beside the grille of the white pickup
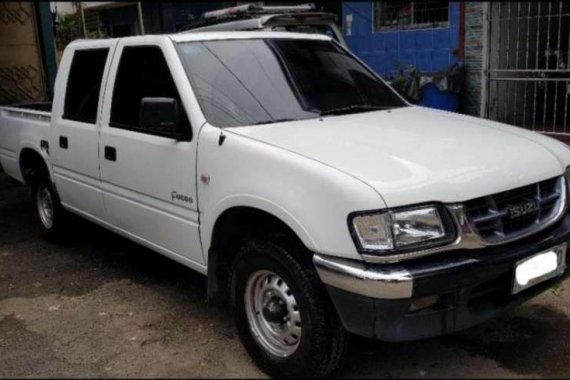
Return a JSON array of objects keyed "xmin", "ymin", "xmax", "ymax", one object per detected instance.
[{"xmin": 350, "ymin": 205, "xmax": 455, "ymax": 253}]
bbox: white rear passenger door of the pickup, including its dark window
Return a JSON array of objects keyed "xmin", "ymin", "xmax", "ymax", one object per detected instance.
[{"xmin": 49, "ymin": 41, "xmax": 115, "ymax": 220}]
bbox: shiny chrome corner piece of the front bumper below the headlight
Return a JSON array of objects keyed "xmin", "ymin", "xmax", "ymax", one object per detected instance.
[{"xmin": 313, "ymin": 254, "xmax": 413, "ymax": 299}]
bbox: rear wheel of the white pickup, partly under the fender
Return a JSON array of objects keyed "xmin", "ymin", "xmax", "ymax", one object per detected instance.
[{"xmin": 32, "ymin": 178, "xmax": 69, "ymax": 243}]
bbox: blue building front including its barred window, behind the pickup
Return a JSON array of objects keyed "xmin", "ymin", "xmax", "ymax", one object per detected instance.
[{"xmin": 342, "ymin": 1, "xmax": 462, "ymax": 79}]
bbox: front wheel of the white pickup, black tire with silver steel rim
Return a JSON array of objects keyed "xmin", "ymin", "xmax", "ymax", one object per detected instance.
[{"xmin": 230, "ymin": 240, "xmax": 347, "ymax": 377}]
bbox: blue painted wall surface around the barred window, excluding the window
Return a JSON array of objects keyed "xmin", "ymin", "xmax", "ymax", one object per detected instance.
[{"xmin": 342, "ymin": 1, "xmax": 459, "ymax": 78}]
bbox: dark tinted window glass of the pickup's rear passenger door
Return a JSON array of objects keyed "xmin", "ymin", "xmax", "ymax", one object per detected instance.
[{"xmin": 63, "ymin": 49, "xmax": 109, "ymax": 124}]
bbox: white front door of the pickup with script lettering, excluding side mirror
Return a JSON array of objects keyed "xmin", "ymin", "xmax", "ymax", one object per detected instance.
[{"xmin": 99, "ymin": 36, "xmax": 204, "ymax": 269}]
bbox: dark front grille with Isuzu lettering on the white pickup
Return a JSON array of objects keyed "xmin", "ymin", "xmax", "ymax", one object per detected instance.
[{"xmin": 465, "ymin": 177, "xmax": 565, "ymax": 243}]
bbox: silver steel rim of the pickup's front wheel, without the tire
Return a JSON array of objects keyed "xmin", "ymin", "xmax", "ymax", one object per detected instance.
[{"xmin": 244, "ymin": 270, "xmax": 301, "ymax": 357}]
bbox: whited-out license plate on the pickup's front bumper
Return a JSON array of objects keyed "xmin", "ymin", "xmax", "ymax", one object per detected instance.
[{"xmin": 512, "ymin": 243, "xmax": 567, "ymax": 294}]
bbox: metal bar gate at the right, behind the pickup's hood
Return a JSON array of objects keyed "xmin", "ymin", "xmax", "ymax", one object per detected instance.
[{"xmin": 484, "ymin": 1, "xmax": 570, "ymax": 137}]
